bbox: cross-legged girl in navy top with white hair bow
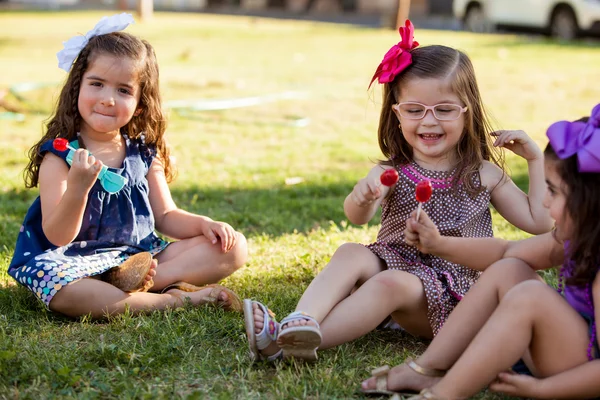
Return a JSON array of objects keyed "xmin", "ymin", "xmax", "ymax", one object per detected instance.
[{"xmin": 8, "ymin": 14, "xmax": 247, "ymax": 318}]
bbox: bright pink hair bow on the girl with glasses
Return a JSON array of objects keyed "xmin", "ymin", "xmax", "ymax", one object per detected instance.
[{"xmin": 369, "ymin": 19, "xmax": 419, "ymax": 87}]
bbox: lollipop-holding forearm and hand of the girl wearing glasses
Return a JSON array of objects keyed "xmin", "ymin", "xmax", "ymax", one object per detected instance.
[{"xmin": 344, "ymin": 165, "xmax": 393, "ymax": 225}]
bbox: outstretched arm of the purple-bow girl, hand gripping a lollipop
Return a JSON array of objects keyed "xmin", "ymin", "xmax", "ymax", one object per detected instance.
[{"xmin": 404, "ymin": 210, "xmax": 564, "ymax": 271}]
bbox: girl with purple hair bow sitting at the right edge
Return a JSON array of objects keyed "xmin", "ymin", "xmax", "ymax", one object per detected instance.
[{"xmin": 363, "ymin": 104, "xmax": 600, "ymax": 399}]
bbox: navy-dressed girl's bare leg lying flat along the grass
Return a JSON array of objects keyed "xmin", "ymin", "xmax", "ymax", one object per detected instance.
[{"xmin": 50, "ymin": 278, "xmax": 234, "ymax": 318}]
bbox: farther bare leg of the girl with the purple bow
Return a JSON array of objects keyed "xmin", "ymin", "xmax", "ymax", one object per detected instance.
[{"xmin": 362, "ymin": 259, "xmax": 541, "ymax": 391}]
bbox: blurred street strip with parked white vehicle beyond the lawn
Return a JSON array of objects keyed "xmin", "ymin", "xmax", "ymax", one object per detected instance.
[{"xmin": 0, "ymin": 0, "xmax": 600, "ymax": 40}]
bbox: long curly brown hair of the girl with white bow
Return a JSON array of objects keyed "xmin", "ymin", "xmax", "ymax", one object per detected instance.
[{"xmin": 24, "ymin": 32, "xmax": 175, "ymax": 188}]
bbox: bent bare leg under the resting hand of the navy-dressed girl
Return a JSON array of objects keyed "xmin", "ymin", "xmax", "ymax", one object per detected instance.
[{"xmin": 152, "ymin": 233, "xmax": 248, "ymax": 291}]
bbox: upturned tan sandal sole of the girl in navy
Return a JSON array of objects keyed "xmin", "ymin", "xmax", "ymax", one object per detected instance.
[{"xmin": 100, "ymin": 252, "xmax": 154, "ymax": 293}]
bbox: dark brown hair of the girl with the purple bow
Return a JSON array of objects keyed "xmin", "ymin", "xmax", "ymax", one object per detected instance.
[{"xmin": 544, "ymin": 131, "xmax": 600, "ymax": 286}]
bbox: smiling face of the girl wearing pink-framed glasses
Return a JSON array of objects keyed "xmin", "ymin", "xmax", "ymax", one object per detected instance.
[{"xmin": 392, "ymin": 78, "xmax": 465, "ymax": 169}]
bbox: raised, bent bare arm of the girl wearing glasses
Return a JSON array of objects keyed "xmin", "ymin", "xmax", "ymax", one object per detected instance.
[{"xmin": 481, "ymin": 130, "xmax": 554, "ymax": 235}]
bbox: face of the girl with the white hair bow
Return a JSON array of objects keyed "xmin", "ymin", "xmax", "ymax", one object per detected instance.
[{"xmin": 77, "ymin": 54, "xmax": 140, "ymax": 140}]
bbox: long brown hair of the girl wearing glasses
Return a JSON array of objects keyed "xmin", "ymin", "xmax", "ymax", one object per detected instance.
[{"xmin": 377, "ymin": 45, "xmax": 504, "ymax": 195}]
